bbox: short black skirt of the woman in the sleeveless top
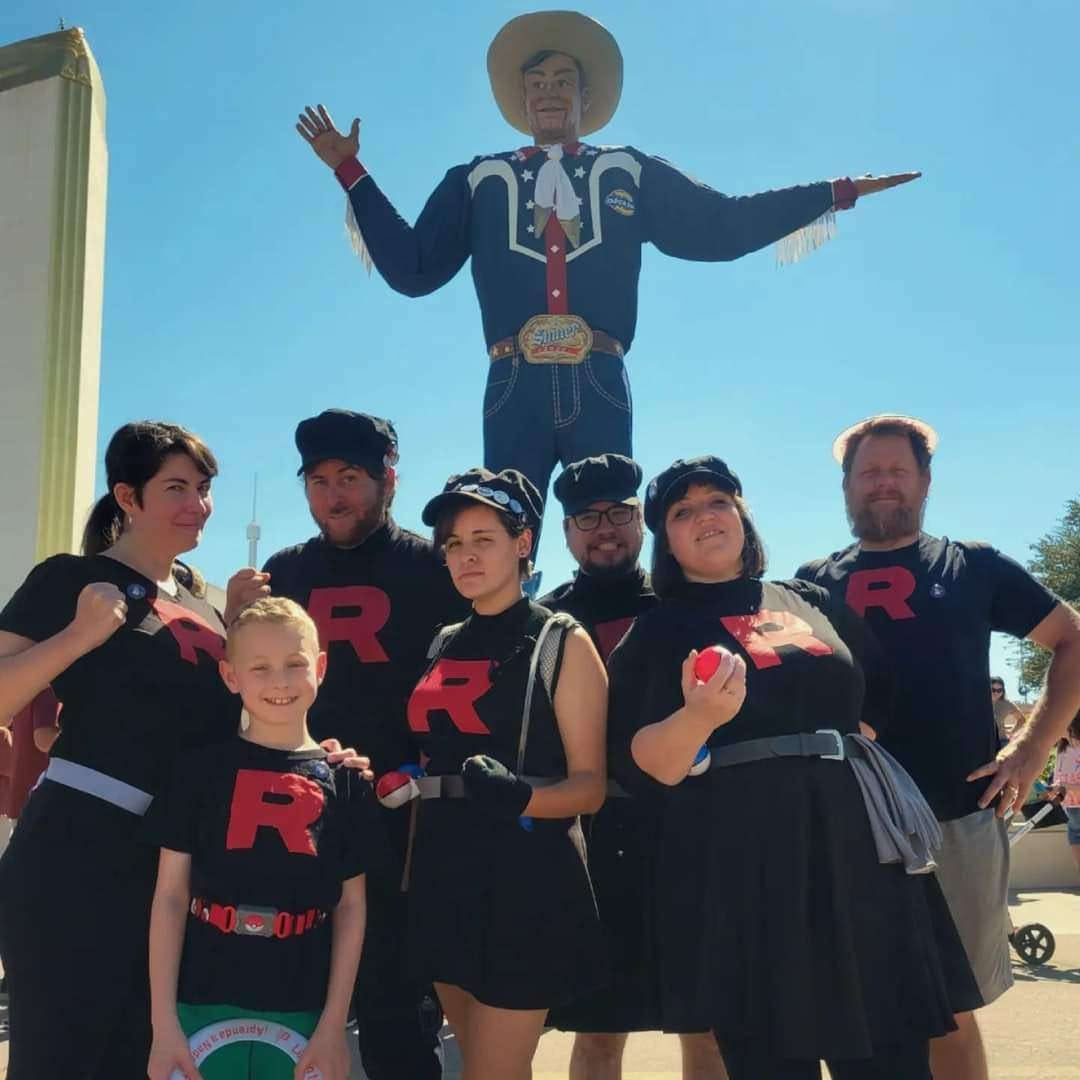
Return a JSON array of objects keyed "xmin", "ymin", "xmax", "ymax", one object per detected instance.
[{"xmin": 409, "ymin": 799, "xmax": 607, "ymax": 1009}]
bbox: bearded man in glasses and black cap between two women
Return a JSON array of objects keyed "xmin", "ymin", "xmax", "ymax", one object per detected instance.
[{"xmin": 539, "ymin": 454, "xmax": 726, "ymax": 1080}]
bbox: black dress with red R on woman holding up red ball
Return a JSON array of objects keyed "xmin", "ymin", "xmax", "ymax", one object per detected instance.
[{"xmin": 609, "ymin": 579, "xmax": 975, "ymax": 1059}]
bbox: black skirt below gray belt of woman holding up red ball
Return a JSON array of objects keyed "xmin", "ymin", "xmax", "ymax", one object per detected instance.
[{"xmin": 657, "ymin": 758, "xmax": 978, "ymax": 1058}]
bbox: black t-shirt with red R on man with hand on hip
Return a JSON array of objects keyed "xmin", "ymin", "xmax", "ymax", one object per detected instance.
[{"xmin": 798, "ymin": 534, "xmax": 1058, "ymax": 821}]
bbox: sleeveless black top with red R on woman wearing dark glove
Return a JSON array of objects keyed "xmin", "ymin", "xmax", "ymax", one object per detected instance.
[{"xmin": 408, "ymin": 597, "xmax": 566, "ymax": 778}]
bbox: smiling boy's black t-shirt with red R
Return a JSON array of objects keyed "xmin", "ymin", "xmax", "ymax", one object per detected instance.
[{"xmin": 147, "ymin": 737, "xmax": 378, "ymax": 1012}]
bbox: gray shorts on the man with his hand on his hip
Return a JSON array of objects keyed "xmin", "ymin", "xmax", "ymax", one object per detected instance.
[{"xmin": 936, "ymin": 810, "xmax": 1013, "ymax": 1004}]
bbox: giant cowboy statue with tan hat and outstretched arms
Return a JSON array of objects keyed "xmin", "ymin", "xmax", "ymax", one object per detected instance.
[{"xmin": 296, "ymin": 11, "xmax": 919, "ymax": 505}]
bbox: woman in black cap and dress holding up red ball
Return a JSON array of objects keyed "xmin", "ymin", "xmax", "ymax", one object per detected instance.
[{"xmin": 609, "ymin": 457, "xmax": 977, "ymax": 1080}]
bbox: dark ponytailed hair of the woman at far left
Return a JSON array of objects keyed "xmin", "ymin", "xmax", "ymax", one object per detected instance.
[{"xmin": 82, "ymin": 420, "xmax": 217, "ymax": 555}]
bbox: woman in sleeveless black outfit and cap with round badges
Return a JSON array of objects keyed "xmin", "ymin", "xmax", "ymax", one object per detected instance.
[{"xmin": 401, "ymin": 469, "xmax": 607, "ymax": 1080}]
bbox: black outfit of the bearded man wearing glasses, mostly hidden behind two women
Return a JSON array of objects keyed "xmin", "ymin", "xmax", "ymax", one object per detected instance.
[{"xmin": 540, "ymin": 567, "xmax": 662, "ymax": 1032}]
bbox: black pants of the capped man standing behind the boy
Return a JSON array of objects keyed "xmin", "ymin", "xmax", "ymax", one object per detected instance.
[{"xmin": 352, "ymin": 867, "xmax": 443, "ymax": 1080}]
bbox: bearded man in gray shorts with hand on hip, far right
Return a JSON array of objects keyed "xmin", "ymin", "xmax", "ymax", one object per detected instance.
[{"xmin": 797, "ymin": 414, "xmax": 1080, "ymax": 1080}]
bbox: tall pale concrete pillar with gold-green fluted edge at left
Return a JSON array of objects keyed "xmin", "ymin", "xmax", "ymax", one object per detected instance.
[{"xmin": 0, "ymin": 29, "xmax": 108, "ymax": 604}]
